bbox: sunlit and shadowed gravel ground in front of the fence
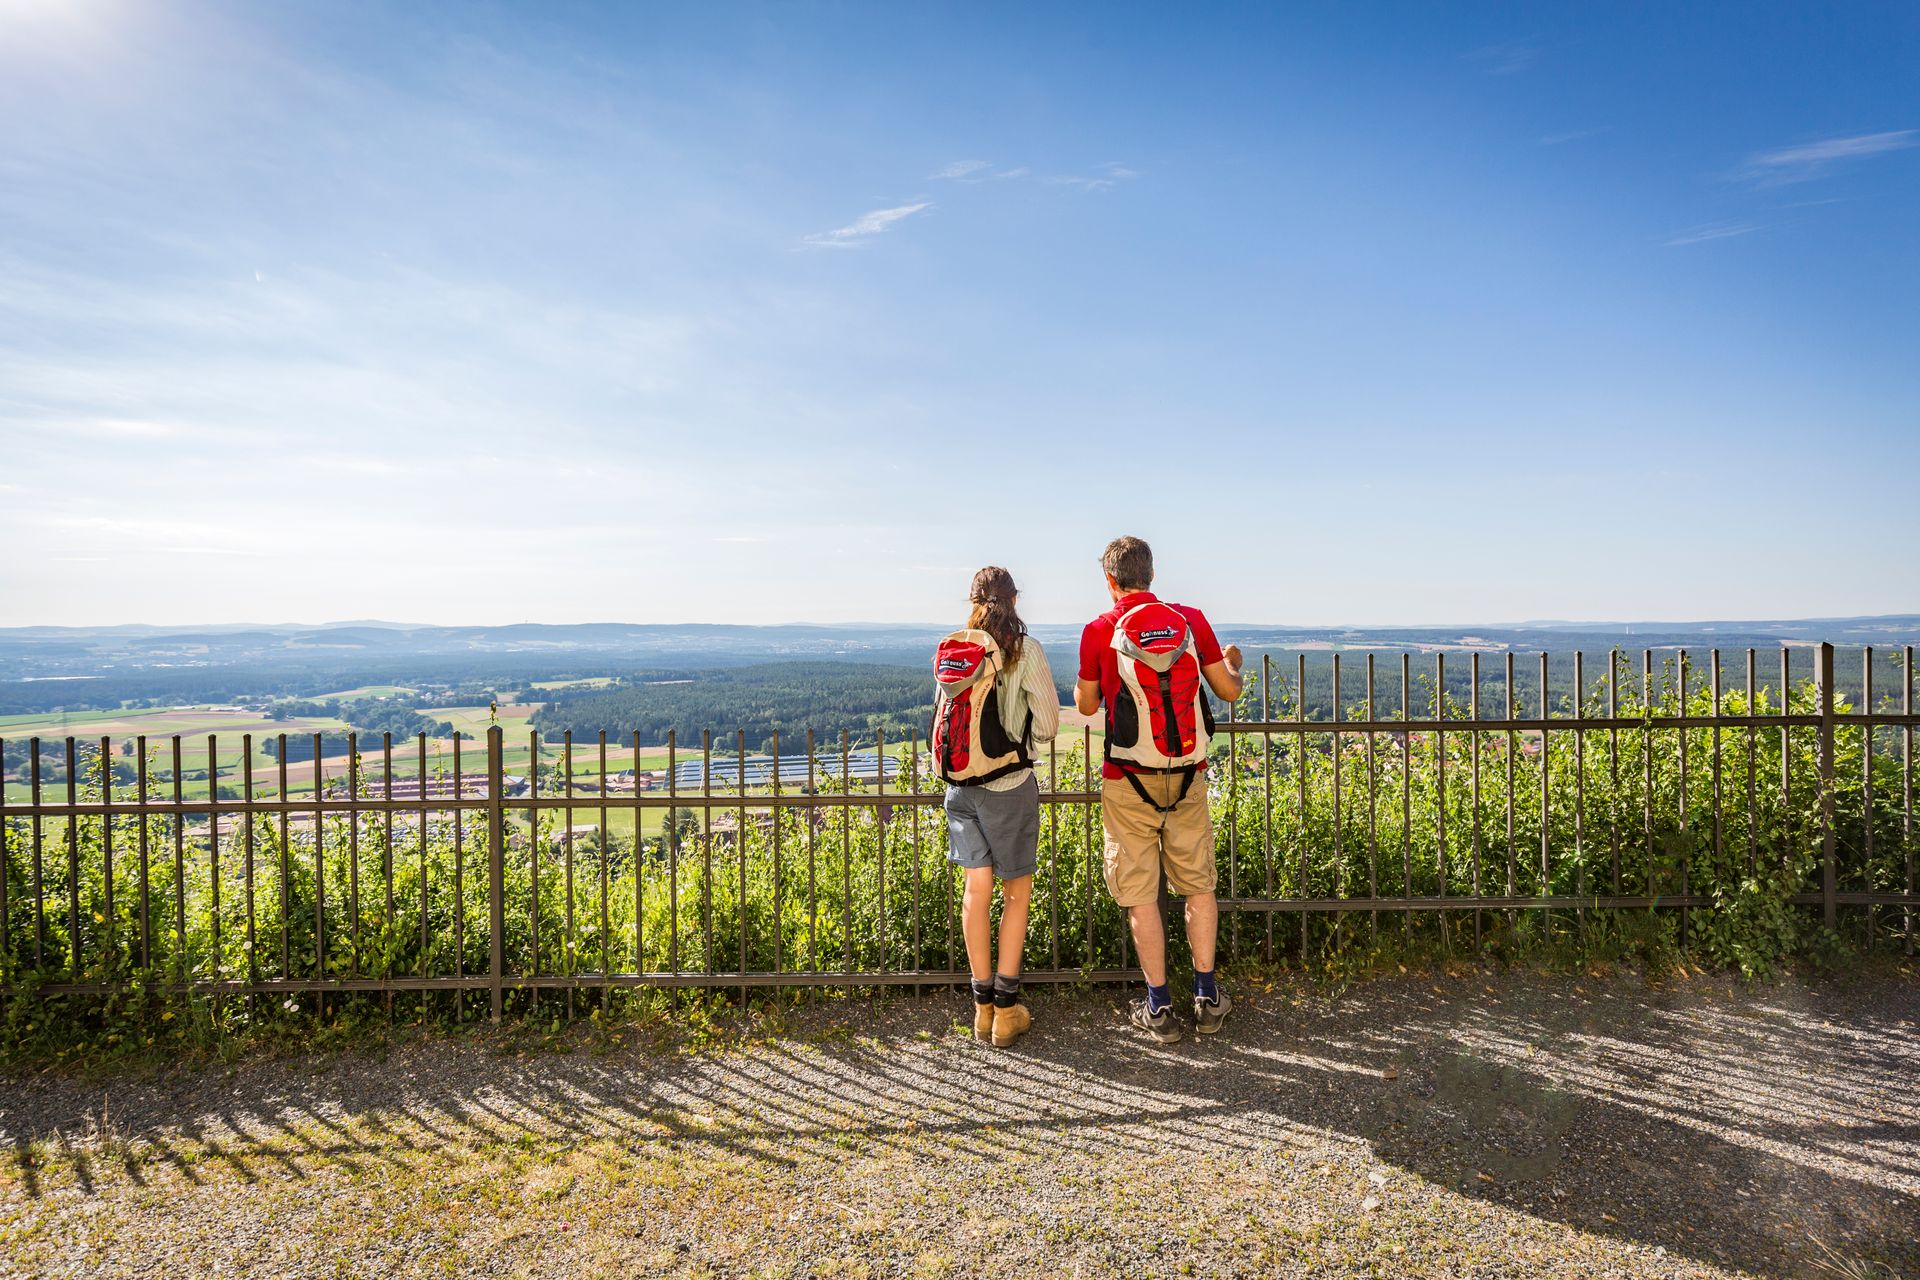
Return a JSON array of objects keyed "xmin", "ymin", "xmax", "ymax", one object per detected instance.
[{"xmin": 0, "ymin": 971, "xmax": 1920, "ymax": 1278}]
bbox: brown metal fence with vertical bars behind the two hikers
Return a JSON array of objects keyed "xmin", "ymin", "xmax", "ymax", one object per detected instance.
[{"xmin": 0, "ymin": 645, "xmax": 1920, "ymax": 1017}]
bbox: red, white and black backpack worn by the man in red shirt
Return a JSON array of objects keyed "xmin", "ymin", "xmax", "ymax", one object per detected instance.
[{"xmin": 1106, "ymin": 601, "xmax": 1213, "ymax": 814}]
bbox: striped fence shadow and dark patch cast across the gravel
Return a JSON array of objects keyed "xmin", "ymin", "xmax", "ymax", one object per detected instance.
[{"xmin": 0, "ymin": 977, "xmax": 1920, "ymax": 1276}]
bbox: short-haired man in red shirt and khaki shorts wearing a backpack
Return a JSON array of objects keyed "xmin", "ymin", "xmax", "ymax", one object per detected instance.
[{"xmin": 1073, "ymin": 537, "xmax": 1242, "ymax": 1044}]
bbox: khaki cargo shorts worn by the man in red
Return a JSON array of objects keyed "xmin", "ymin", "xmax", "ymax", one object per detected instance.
[{"xmin": 1100, "ymin": 771, "xmax": 1215, "ymax": 908}]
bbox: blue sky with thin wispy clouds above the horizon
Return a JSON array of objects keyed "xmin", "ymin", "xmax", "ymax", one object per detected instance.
[{"xmin": 0, "ymin": 0, "xmax": 1920, "ymax": 626}]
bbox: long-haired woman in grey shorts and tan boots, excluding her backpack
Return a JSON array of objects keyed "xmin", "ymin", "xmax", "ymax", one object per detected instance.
[{"xmin": 937, "ymin": 564, "xmax": 1060, "ymax": 1048}]
